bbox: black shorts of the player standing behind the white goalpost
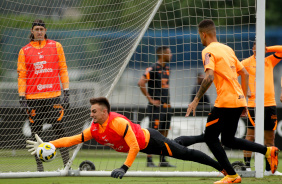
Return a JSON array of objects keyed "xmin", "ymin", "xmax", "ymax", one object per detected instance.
[{"xmin": 247, "ymin": 106, "xmax": 277, "ymax": 130}]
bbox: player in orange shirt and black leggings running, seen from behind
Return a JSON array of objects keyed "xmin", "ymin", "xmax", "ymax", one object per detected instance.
[{"xmin": 186, "ymin": 20, "xmax": 278, "ymax": 183}]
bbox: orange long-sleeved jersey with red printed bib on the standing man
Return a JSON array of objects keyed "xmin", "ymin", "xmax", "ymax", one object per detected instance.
[{"xmin": 17, "ymin": 40, "xmax": 69, "ymax": 99}]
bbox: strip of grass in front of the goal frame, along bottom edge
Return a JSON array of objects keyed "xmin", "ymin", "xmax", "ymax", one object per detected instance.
[{"xmin": 0, "ymin": 176, "xmax": 282, "ymax": 184}]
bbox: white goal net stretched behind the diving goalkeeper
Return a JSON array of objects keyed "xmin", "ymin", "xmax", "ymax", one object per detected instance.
[{"xmin": 0, "ymin": 0, "xmax": 256, "ymax": 177}]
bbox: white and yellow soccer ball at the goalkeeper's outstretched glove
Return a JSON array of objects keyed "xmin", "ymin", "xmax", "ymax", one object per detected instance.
[{"xmin": 36, "ymin": 142, "xmax": 57, "ymax": 162}]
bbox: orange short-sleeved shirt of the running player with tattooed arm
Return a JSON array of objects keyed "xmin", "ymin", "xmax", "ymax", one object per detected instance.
[{"xmin": 202, "ymin": 42, "xmax": 247, "ymax": 108}]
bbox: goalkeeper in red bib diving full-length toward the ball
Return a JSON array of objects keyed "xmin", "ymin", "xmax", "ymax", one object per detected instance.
[{"xmin": 27, "ymin": 97, "xmax": 225, "ymax": 179}]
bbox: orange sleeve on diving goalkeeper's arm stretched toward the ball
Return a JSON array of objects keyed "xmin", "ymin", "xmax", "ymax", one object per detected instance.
[{"xmin": 50, "ymin": 127, "xmax": 92, "ymax": 148}]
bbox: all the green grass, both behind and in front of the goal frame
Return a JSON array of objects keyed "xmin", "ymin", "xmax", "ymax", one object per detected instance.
[{"xmin": 0, "ymin": 150, "xmax": 282, "ymax": 184}]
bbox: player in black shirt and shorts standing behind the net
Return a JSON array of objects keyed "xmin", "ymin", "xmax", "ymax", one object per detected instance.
[{"xmin": 138, "ymin": 46, "xmax": 175, "ymax": 167}]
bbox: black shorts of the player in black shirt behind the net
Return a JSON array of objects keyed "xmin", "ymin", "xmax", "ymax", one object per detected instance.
[{"xmin": 147, "ymin": 104, "xmax": 172, "ymax": 130}]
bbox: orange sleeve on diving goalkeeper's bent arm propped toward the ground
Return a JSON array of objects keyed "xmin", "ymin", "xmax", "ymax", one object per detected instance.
[{"xmin": 112, "ymin": 117, "xmax": 140, "ymax": 167}]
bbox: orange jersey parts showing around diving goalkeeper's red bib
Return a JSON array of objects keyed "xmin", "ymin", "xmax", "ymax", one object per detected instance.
[{"xmin": 50, "ymin": 117, "xmax": 150, "ymax": 167}]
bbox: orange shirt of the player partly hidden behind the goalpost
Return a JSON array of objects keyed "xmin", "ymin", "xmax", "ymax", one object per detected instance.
[{"xmin": 242, "ymin": 46, "xmax": 282, "ymax": 107}]
